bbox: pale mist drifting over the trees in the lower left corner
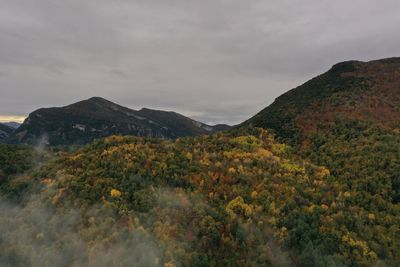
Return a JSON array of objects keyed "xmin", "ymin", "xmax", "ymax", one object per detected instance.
[{"xmin": 0, "ymin": 191, "xmax": 162, "ymax": 267}]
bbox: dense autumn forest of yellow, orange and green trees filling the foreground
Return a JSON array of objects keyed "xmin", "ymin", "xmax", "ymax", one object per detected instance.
[{"xmin": 0, "ymin": 126, "xmax": 400, "ymax": 266}]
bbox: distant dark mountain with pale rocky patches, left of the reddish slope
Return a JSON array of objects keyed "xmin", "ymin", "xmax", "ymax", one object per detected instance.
[{"xmin": 11, "ymin": 97, "xmax": 231, "ymax": 145}]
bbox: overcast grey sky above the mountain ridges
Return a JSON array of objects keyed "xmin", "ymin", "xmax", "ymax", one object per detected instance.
[{"xmin": 0, "ymin": 0, "xmax": 400, "ymax": 124}]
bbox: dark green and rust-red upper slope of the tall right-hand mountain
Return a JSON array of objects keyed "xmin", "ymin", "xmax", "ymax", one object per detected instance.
[{"xmin": 241, "ymin": 58, "xmax": 400, "ymax": 141}]
